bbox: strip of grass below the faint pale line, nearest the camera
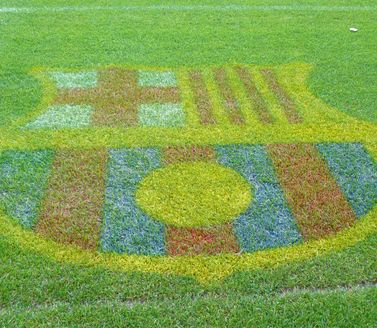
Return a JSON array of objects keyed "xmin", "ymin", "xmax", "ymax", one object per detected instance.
[{"xmin": 0, "ymin": 288, "xmax": 377, "ymax": 327}]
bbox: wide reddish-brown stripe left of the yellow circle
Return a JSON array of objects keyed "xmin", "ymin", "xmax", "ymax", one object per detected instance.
[{"xmin": 36, "ymin": 150, "xmax": 107, "ymax": 249}]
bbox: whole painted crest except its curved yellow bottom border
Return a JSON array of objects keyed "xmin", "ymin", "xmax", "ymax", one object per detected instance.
[{"xmin": 0, "ymin": 56, "xmax": 377, "ymax": 275}]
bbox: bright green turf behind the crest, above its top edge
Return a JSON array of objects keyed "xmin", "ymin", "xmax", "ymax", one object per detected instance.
[{"xmin": 0, "ymin": 0, "xmax": 377, "ymax": 126}]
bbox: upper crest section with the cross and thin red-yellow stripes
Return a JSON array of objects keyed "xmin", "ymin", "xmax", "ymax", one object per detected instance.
[{"xmin": 23, "ymin": 64, "xmax": 354, "ymax": 131}]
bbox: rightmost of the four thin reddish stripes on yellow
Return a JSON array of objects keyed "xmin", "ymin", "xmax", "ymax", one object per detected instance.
[{"xmin": 261, "ymin": 69, "xmax": 303, "ymax": 124}]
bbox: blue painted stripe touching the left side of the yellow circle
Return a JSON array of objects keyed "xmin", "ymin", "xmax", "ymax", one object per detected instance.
[{"xmin": 101, "ymin": 149, "xmax": 165, "ymax": 255}]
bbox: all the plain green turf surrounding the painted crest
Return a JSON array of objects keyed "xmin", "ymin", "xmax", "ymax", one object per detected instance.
[{"xmin": 0, "ymin": 0, "xmax": 377, "ymax": 327}]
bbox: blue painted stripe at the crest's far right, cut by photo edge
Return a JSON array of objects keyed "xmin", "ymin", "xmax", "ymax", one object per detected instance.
[{"xmin": 317, "ymin": 143, "xmax": 377, "ymax": 217}]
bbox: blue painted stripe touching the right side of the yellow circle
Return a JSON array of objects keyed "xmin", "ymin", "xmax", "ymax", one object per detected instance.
[{"xmin": 216, "ymin": 145, "xmax": 302, "ymax": 252}]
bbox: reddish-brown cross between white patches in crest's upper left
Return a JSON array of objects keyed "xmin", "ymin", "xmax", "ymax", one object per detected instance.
[{"xmin": 55, "ymin": 68, "xmax": 183, "ymax": 127}]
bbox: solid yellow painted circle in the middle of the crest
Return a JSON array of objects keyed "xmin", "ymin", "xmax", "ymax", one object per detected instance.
[{"xmin": 136, "ymin": 162, "xmax": 251, "ymax": 227}]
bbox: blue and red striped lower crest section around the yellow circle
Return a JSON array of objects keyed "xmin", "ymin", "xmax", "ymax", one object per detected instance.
[{"xmin": 0, "ymin": 143, "xmax": 377, "ymax": 280}]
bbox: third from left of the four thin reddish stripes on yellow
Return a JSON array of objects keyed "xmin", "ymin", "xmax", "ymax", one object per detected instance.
[{"xmin": 235, "ymin": 66, "xmax": 274, "ymax": 124}]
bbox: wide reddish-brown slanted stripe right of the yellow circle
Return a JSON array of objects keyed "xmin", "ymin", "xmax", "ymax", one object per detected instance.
[{"xmin": 268, "ymin": 144, "xmax": 356, "ymax": 240}]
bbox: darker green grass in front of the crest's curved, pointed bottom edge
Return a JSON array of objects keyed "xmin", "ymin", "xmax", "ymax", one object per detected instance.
[{"xmin": 0, "ymin": 235, "xmax": 377, "ymax": 327}]
